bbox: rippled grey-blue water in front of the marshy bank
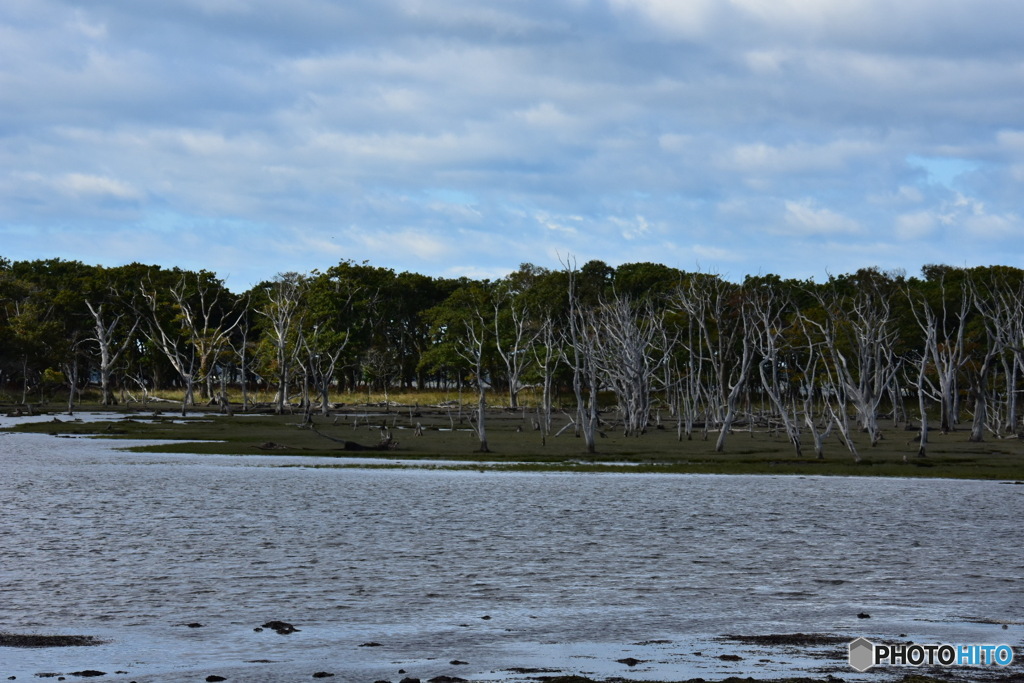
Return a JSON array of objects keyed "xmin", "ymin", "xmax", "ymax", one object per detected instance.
[{"xmin": 0, "ymin": 421, "xmax": 1024, "ymax": 683}]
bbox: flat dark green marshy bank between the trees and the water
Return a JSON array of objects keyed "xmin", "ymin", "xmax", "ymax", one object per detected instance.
[{"xmin": 0, "ymin": 403, "xmax": 1024, "ymax": 480}]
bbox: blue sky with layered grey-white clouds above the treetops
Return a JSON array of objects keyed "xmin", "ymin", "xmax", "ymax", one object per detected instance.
[{"xmin": 0, "ymin": 0, "xmax": 1024, "ymax": 291}]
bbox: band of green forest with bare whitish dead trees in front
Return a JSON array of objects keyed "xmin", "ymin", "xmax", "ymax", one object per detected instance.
[{"xmin": 0, "ymin": 253, "xmax": 1024, "ymax": 461}]
